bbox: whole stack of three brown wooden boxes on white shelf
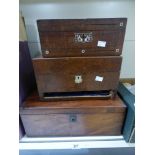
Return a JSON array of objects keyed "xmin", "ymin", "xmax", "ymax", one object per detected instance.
[{"xmin": 20, "ymin": 18, "xmax": 127, "ymax": 136}]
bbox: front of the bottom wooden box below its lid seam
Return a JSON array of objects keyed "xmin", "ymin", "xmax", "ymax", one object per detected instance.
[{"xmin": 21, "ymin": 113, "xmax": 124, "ymax": 136}]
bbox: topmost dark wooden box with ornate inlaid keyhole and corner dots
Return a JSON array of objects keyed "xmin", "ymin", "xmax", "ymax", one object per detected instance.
[{"xmin": 37, "ymin": 18, "xmax": 127, "ymax": 58}]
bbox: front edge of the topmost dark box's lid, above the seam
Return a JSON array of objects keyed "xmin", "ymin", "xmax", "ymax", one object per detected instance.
[{"xmin": 37, "ymin": 18, "xmax": 127, "ymax": 32}]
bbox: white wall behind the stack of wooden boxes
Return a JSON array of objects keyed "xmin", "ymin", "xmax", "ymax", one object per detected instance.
[{"xmin": 19, "ymin": 0, "xmax": 135, "ymax": 78}]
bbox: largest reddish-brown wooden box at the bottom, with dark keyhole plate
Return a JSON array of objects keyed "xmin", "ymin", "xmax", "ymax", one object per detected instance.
[{"xmin": 20, "ymin": 94, "xmax": 126, "ymax": 137}]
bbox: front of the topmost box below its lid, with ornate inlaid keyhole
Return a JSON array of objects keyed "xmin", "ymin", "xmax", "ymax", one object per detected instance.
[{"xmin": 40, "ymin": 31, "xmax": 121, "ymax": 57}]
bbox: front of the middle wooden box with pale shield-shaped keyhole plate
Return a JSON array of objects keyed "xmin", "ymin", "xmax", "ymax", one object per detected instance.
[{"xmin": 33, "ymin": 57, "xmax": 122, "ymax": 93}]
